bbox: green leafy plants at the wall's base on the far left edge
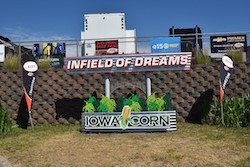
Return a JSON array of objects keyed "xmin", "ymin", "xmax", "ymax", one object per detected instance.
[{"xmin": 0, "ymin": 103, "xmax": 12, "ymax": 134}]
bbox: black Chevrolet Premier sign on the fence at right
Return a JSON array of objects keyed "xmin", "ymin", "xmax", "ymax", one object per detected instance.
[{"xmin": 210, "ymin": 35, "xmax": 247, "ymax": 53}]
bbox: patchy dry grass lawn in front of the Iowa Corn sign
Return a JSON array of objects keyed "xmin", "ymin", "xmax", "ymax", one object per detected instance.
[{"xmin": 0, "ymin": 123, "xmax": 250, "ymax": 167}]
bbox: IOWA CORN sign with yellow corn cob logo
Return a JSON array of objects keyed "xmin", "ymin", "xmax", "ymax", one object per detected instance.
[{"xmin": 82, "ymin": 110, "xmax": 176, "ymax": 133}]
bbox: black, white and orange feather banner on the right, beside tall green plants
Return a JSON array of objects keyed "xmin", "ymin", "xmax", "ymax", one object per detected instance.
[{"xmin": 220, "ymin": 55, "xmax": 233, "ymax": 103}]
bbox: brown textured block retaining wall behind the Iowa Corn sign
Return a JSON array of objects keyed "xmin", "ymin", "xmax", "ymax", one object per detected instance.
[{"xmin": 0, "ymin": 61, "xmax": 250, "ymax": 124}]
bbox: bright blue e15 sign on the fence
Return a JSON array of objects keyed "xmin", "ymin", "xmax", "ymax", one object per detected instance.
[{"xmin": 150, "ymin": 37, "xmax": 181, "ymax": 53}]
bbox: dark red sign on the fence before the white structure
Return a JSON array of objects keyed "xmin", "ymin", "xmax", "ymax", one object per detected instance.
[{"xmin": 95, "ymin": 40, "xmax": 118, "ymax": 55}]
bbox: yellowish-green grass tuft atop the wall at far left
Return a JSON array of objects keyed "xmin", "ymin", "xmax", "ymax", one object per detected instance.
[{"xmin": 3, "ymin": 55, "xmax": 19, "ymax": 70}]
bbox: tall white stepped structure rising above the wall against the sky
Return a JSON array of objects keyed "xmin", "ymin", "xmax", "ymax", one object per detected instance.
[{"xmin": 81, "ymin": 13, "xmax": 136, "ymax": 56}]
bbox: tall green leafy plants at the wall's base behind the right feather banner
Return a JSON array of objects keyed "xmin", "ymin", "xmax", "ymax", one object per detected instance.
[{"xmin": 211, "ymin": 93, "xmax": 250, "ymax": 127}]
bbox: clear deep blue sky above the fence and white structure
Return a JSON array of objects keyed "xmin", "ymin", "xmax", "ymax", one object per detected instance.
[{"xmin": 0, "ymin": 0, "xmax": 250, "ymax": 45}]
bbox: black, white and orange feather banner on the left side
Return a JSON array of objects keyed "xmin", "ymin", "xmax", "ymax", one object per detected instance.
[{"xmin": 23, "ymin": 61, "xmax": 38, "ymax": 111}]
